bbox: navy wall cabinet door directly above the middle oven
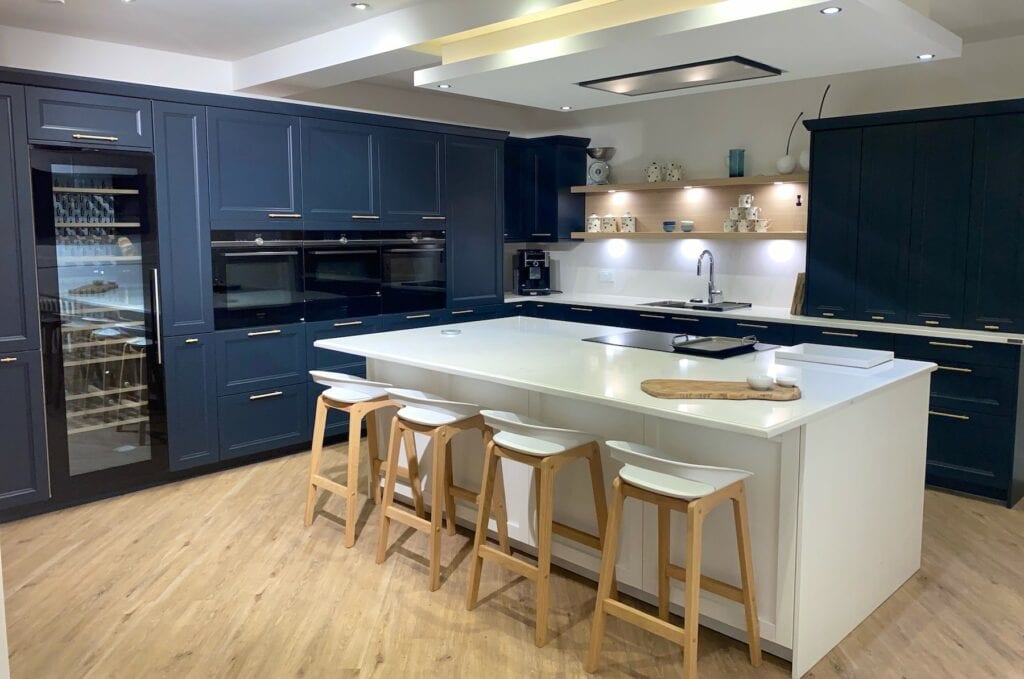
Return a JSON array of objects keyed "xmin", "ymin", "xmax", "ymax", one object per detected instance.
[{"xmin": 301, "ymin": 118, "xmax": 380, "ymax": 228}]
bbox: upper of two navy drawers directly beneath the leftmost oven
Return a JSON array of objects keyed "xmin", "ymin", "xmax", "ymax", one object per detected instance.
[{"xmin": 215, "ymin": 324, "xmax": 306, "ymax": 395}]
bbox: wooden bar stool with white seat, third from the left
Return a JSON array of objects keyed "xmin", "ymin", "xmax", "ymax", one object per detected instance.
[{"xmin": 466, "ymin": 411, "xmax": 608, "ymax": 646}]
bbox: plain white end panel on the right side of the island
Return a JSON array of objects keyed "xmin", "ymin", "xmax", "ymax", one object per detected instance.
[{"xmin": 793, "ymin": 374, "xmax": 931, "ymax": 677}]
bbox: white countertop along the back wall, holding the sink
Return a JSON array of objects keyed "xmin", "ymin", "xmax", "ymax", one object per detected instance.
[{"xmin": 505, "ymin": 293, "xmax": 1024, "ymax": 344}]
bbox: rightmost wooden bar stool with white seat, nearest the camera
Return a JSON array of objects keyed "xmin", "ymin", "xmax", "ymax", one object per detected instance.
[{"xmin": 587, "ymin": 441, "xmax": 761, "ymax": 679}]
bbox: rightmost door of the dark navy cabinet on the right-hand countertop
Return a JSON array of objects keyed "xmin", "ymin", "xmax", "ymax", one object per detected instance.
[{"xmin": 964, "ymin": 114, "xmax": 1024, "ymax": 333}]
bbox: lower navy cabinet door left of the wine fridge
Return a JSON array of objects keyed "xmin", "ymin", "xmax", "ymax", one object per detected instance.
[{"xmin": 0, "ymin": 351, "xmax": 50, "ymax": 509}]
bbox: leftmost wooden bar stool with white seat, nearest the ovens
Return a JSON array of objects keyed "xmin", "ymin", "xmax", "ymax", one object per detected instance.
[{"xmin": 305, "ymin": 370, "xmax": 401, "ymax": 547}]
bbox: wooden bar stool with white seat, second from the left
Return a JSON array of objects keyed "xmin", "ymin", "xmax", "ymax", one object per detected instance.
[{"xmin": 377, "ymin": 389, "xmax": 511, "ymax": 592}]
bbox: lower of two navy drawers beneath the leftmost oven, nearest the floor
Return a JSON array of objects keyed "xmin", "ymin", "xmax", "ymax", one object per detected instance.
[{"xmin": 217, "ymin": 382, "xmax": 309, "ymax": 460}]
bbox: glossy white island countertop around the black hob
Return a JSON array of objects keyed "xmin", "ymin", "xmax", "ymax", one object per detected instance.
[{"xmin": 314, "ymin": 316, "xmax": 935, "ymax": 438}]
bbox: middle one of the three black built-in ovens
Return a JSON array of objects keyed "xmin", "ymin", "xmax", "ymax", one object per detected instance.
[{"xmin": 302, "ymin": 231, "xmax": 381, "ymax": 321}]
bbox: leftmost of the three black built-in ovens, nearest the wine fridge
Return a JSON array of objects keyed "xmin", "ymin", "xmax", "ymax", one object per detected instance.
[{"xmin": 212, "ymin": 230, "xmax": 303, "ymax": 330}]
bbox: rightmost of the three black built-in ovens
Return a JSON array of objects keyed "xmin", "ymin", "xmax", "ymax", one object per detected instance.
[{"xmin": 381, "ymin": 230, "xmax": 447, "ymax": 313}]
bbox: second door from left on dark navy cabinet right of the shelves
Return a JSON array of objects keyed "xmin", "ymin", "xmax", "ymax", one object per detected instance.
[{"xmin": 855, "ymin": 124, "xmax": 914, "ymax": 323}]
